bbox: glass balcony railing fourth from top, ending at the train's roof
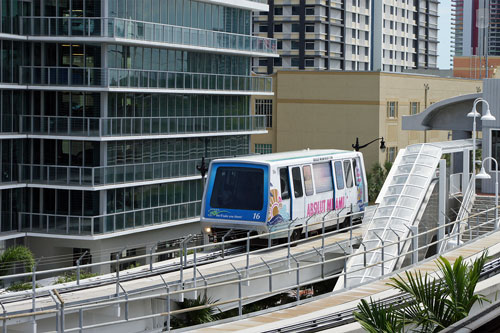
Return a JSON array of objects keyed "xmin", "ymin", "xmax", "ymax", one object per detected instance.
[{"xmin": 19, "ymin": 159, "xmax": 212, "ymax": 187}]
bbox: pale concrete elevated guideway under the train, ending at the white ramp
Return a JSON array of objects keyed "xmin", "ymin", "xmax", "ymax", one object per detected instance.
[{"xmin": 0, "ymin": 217, "xmax": 363, "ymax": 333}]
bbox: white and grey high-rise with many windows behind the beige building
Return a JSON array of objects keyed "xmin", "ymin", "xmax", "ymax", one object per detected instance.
[{"xmin": 253, "ymin": 0, "xmax": 438, "ymax": 73}]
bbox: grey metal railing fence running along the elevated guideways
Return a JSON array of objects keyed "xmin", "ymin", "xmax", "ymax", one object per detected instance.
[{"xmin": 0, "ymin": 207, "xmax": 498, "ymax": 332}]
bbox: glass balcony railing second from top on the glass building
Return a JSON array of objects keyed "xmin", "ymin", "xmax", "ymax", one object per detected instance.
[{"xmin": 20, "ymin": 66, "xmax": 272, "ymax": 92}]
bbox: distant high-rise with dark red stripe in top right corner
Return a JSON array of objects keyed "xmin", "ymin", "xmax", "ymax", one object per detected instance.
[{"xmin": 452, "ymin": 0, "xmax": 500, "ymax": 57}]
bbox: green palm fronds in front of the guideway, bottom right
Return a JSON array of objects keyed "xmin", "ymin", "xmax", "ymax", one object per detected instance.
[{"xmin": 354, "ymin": 252, "xmax": 489, "ymax": 333}]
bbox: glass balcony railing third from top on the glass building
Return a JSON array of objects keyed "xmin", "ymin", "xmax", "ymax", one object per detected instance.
[{"xmin": 20, "ymin": 115, "xmax": 266, "ymax": 137}]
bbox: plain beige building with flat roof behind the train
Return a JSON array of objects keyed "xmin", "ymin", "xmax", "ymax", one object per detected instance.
[{"xmin": 251, "ymin": 71, "xmax": 482, "ymax": 167}]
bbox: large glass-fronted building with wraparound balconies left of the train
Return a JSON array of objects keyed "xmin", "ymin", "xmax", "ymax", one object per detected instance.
[{"xmin": 0, "ymin": 0, "xmax": 277, "ymax": 270}]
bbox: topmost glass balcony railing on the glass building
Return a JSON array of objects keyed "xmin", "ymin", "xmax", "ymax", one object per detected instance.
[{"xmin": 21, "ymin": 16, "xmax": 277, "ymax": 55}]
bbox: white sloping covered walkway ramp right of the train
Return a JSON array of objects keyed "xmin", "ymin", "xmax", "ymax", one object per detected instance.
[{"xmin": 335, "ymin": 140, "xmax": 472, "ymax": 289}]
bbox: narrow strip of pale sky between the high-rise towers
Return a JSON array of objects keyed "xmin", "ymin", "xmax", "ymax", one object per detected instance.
[{"xmin": 438, "ymin": 0, "xmax": 451, "ymax": 69}]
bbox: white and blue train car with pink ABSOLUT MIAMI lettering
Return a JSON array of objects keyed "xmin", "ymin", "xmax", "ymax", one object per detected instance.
[{"xmin": 201, "ymin": 149, "xmax": 368, "ymax": 239}]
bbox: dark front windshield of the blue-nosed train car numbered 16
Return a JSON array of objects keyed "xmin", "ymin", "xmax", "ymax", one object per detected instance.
[{"xmin": 210, "ymin": 166, "xmax": 264, "ymax": 211}]
